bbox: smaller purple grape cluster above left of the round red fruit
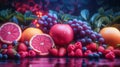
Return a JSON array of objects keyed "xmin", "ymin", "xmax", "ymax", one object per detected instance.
[{"xmin": 38, "ymin": 13, "xmax": 58, "ymax": 33}]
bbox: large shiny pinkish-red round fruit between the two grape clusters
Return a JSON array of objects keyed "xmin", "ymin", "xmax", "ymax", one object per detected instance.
[{"xmin": 50, "ymin": 24, "xmax": 74, "ymax": 46}]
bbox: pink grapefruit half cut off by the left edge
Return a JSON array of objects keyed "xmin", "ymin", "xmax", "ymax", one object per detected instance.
[{"xmin": 0, "ymin": 22, "xmax": 22, "ymax": 44}]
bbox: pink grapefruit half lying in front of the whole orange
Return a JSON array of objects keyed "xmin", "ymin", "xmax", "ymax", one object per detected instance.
[{"xmin": 29, "ymin": 34, "xmax": 54, "ymax": 56}]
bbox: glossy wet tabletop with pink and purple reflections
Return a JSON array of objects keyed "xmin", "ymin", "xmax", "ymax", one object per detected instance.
[{"xmin": 0, "ymin": 58, "xmax": 120, "ymax": 67}]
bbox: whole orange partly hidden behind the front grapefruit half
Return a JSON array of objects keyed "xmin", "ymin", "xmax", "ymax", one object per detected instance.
[{"xmin": 21, "ymin": 27, "xmax": 43, "ymax": 42}]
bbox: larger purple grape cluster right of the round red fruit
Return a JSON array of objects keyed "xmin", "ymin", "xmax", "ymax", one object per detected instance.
[{"xmin": 68, "ymin": 19, "xmax": 104, "ymax": 45}]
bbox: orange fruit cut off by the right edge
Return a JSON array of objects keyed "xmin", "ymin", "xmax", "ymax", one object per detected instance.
[{"xmin": 100, "ymin": 27, "xmax": 120, "ymax": 47}]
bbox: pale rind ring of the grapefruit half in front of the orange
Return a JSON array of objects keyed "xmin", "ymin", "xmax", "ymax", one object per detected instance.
[{"xmin": 29, "ymin": 34, "xmax": 54, "ymax": 56}]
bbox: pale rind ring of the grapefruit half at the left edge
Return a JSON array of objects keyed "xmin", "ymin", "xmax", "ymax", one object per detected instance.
[{"xmin": 0, "ymin": 22, "xmax": 22, "ymax": 44}]
